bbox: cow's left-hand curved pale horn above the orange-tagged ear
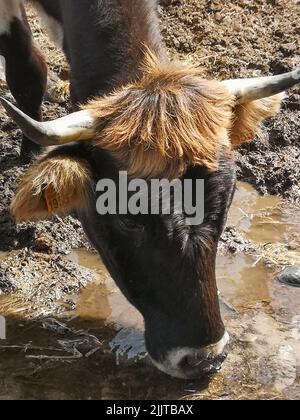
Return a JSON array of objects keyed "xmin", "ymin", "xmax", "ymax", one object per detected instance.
[{"xmin": 0, "ymin": 98, "xmax": 95, "ymax": 146}]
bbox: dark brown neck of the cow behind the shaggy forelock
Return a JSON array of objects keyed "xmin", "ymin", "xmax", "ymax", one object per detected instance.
[{"xmin": 61, "ymin": 0, "xmax": 166, "ymax": 102}]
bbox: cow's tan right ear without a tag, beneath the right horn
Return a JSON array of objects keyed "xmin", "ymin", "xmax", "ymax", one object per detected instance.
[{"xmin": 230, "ymin": 94, "xmax": 285, "ymax": 146}]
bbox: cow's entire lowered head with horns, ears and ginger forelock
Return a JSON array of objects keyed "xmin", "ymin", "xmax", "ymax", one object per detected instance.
[{"xmin": 3, "ymin": 56, "xmax": 299, "ymax": 378}]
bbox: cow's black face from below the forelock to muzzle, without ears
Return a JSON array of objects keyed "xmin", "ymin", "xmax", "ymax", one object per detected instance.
[{"xmin": 66, "ymin": 144, "xmax": 235, "ymax": 378}]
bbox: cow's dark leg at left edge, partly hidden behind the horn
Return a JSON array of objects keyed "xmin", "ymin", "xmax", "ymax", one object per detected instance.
[{"xmin": 0, "ymin": 0, "xmax": 47, "ymax": 163}]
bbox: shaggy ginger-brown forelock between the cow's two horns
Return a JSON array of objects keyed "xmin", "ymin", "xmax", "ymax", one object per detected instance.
[{"xmin": 86, "ymin": 53, "xmax": 234, "ymax": 178}]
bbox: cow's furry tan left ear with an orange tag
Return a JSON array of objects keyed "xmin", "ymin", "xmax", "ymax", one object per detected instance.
[{"xmin": 11, "ymin": 156, "xmax": 92, "ymax": 221}]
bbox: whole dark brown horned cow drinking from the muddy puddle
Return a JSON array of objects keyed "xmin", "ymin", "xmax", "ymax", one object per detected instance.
[{"xmin": 0, "ymin": 0, "xmax": 300, "ymax": 379}]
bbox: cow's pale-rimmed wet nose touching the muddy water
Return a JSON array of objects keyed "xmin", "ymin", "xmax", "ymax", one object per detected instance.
[{"xmin": 150, "ymin": 333, "xmax": 229, "ymax": 379}]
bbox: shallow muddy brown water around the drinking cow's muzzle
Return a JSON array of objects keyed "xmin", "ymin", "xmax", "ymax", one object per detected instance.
[{"xmin": 0, "ymin": 183, "xmax": 300, "ymax": 399}]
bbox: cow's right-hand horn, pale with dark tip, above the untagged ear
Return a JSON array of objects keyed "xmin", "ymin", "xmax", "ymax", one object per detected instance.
[{"xmin": 222, "ymin": 68, "xmax": 300, "ymax": 104}]
